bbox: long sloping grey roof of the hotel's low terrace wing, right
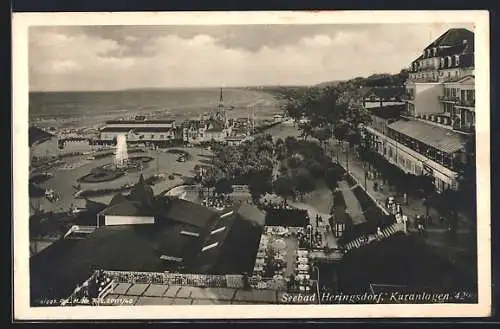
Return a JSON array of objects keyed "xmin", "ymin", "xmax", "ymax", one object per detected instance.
[{"xmin": 387, "ymin": 120, "xmax": 466, "ymax": 154}]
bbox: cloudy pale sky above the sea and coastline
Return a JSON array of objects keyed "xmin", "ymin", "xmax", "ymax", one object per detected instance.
[{"xmin": 28, "ymin": 24, "xmax": 473, "ymax": 91}]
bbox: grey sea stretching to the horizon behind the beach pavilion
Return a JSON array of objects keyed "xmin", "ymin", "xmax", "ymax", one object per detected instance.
[{"xmin": 29, "ymin": 88, "xmax": 281, "ymax": 128}]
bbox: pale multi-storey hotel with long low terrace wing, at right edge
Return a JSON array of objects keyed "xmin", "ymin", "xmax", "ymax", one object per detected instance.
[{"xmin": 366, "ymin": 29, "xmax": 475, "ymax": 192}]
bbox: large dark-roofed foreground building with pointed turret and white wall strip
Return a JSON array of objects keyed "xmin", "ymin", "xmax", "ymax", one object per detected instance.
[{"xmin": 30, "ymin": 178, "xmax": 261, "ymax": 302}]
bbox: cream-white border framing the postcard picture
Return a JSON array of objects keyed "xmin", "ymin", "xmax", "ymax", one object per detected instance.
[{"xmin": 12, "ymin": 11, "xmax": 491, "ymax": 320}]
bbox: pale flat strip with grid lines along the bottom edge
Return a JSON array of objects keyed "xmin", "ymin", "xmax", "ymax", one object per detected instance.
[{"xmin": 105, "ymin": 283, "xmax": 279, "ymax": 306}]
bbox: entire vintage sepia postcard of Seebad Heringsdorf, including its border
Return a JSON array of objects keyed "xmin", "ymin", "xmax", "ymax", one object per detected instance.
[{"xmin": 12, "ymin": 11, "xmax": 491, "ymax": 320}]
